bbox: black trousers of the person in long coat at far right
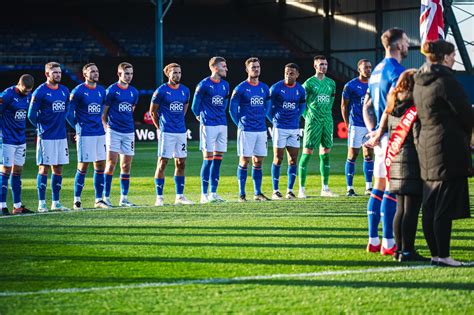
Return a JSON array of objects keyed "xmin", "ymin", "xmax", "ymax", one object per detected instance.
[{"xmin": 422, "ymin": 178, "xmax": 470, "ymax": 258}]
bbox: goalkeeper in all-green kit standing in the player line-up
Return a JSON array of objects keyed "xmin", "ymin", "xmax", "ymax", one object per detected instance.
[{"xmin": 298, "ymin": 55, "xmax": 338, "ymax": 198}]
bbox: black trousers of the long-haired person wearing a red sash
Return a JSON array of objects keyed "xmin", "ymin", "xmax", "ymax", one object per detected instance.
[{"xmin": 393, "ymin": 195, "xmax": 422, "ymax": 252}]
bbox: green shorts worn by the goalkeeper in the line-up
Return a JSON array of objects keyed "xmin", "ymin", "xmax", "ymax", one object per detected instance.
[{"xmin": 303, "ymin": 117, "xmax": 334, "ymax": 150}]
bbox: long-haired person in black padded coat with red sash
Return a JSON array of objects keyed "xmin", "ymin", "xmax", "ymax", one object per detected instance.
[{"xmin": 385, "ymin": 69, "xmax": 429, "ymax": 261}]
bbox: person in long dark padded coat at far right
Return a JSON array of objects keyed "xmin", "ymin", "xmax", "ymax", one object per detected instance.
[{"xmin": 413, "ymin": 40, "xmax": 474, "ymax": 267}]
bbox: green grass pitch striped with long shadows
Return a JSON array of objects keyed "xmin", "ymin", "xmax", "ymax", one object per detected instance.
[{"xmin": 0, "ymin": 141, "xmax": 474, "ymax": 314}]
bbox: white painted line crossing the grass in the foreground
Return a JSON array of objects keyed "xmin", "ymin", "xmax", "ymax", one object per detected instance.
[{"xmin": 0, "ymin": 262, "xmax": 474, "ymax": 297}]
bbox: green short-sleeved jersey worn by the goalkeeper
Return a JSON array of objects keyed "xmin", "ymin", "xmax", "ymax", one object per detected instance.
[{"xmin": 303, "ymin": 76, "xmax": 336, "ymax": 121}]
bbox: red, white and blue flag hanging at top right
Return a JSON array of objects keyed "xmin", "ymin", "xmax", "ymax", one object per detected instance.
[{"xmin": 420, "ymin": 0, "xmax": 444, "ymax": 52}]
